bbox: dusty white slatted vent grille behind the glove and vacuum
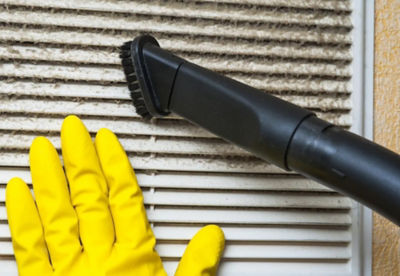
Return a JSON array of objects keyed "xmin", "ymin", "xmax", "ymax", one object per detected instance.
[{"xmin": 0, "ymin": 0, "xmax": 356, "ymax": 275}]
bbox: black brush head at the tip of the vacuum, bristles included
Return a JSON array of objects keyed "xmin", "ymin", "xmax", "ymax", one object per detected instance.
[{"xmin": 120, "ymin": 35, "xmax": 184, "ymax": 119}]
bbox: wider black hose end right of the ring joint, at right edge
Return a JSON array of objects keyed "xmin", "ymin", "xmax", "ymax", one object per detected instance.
[{"xmin": 287, "ymin": 116, "xmax": 400, "ymax": 225}]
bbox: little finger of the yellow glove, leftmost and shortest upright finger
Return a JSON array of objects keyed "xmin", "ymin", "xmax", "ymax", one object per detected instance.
[{"xmin": 6, "ymin": 178, "xmax": 52, "ymax": 276}]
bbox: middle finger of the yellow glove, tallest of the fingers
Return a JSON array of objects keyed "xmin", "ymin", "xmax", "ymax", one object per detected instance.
[{"xmin": 61, "ymin": 116, "xmax": 115, "ymax": 263}]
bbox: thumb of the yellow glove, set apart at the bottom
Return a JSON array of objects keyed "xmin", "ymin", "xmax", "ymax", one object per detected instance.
[{"xmin": 175, "ymin": 225, "xmax": 225, "ymax": 276}]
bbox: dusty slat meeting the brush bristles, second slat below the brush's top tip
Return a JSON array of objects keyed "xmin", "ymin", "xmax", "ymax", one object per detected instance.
[{"xmin": 0, "ymin": 45, "xmax": 351, "ymax": 77}]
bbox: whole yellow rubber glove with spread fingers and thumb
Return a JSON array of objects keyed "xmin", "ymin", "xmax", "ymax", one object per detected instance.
[{"xmin": 6, "ymin": 116, "xmax": 224, "ymax": 276}]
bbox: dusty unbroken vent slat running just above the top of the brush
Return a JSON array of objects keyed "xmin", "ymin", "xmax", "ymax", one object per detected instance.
[{"xmin": 0, "ymin": 7, "xmax": 351, "ymax": 44}]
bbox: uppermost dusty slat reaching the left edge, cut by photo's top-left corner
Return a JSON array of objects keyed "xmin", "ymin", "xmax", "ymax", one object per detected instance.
[{"xmin": 2, "ymin": 0, "xmax": 352, "ymax": 27}]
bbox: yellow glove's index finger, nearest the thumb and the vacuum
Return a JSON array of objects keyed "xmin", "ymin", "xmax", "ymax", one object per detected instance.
[{"xmin": 95, "ymin": 129, "xmax": 155, "ymax": 250}]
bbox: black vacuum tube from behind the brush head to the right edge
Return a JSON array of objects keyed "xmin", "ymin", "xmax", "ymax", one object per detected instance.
[{"xmin": 170, "ymin": 59, "xmax": 400, "ymax": 225}]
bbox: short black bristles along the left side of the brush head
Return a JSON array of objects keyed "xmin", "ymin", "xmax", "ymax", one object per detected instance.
[{"xmin": 119, "ymin": 41, "xmax": 152, "ymax": 119}]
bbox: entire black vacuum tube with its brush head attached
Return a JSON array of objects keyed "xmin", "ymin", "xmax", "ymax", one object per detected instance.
[{"xmin": 120, "ymin": 36, "xmax": 400, "ymax": 225}]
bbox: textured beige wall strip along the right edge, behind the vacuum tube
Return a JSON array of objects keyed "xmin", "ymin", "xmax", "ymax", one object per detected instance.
[{"xmin": 372, "ymin": 0, "xmax": 400, "ymax": 276}]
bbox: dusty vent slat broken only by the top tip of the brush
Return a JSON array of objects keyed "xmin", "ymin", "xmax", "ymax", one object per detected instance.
[{"xmin": 0, "ymin": 26, "xmax": 351, "ymax": 61}]
